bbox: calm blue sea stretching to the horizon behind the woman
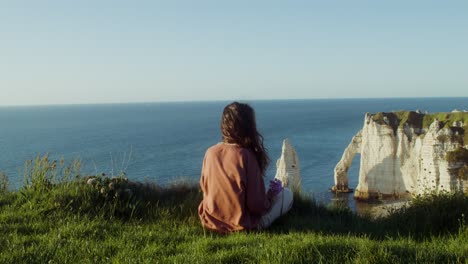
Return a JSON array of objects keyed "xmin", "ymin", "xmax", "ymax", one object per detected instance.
[{"xmin": 0, "ymin": 98, "xmax": 468, "ymax": 200}]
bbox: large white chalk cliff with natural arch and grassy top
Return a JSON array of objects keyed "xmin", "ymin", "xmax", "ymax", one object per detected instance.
[{"xmin": 333, "ymin": 112, "xmax": 468, "ymax": 199}]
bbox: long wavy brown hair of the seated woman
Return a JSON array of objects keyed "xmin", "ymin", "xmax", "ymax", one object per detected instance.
[{"xmin": 221, "ymin": 102, "xmax": 270, "ymax": 175}]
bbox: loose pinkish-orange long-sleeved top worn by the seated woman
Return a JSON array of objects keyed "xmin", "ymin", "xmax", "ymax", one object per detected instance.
[{"xmin": 198, "ymin": 143, "xmax": 271, "ymax": 233}]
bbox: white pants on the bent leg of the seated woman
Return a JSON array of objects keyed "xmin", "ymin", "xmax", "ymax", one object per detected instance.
[{"xmin": 259, "ymin": 188, "xmax": 293, "ymax": 229}]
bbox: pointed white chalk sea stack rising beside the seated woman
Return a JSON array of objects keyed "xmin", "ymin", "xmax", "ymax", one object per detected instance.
[{"xmin": 275, "ymin": 139, "xmax": 302, "ymax": 192}]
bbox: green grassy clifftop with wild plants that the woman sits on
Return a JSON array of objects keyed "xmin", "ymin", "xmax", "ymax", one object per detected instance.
[{"xmin": 0, "ymin": 158, "xmax": 468, "ymax": 263}]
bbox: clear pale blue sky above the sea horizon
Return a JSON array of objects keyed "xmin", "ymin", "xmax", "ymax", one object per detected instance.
[{"xmin": 0, "ymin": 0, "xmax": 468, "ymax": 105}]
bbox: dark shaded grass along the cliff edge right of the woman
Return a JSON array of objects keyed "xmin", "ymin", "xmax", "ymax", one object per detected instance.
[{"xmin": 270, "ymin": 193, "xmax": 468, "ymax": 240}]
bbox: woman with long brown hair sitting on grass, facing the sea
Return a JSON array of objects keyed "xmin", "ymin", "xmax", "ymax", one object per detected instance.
[{"xmin": 198, "ymin": 102, "xmax": 293, "ymax": 233}]
